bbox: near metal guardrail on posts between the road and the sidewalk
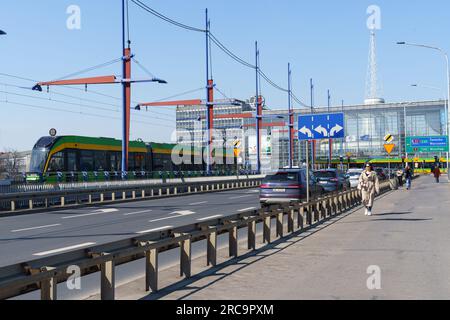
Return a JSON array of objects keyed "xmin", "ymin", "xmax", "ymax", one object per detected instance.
[{"xmin": 0, "ymin": 183, "xmax": 390, "ymax": 300}]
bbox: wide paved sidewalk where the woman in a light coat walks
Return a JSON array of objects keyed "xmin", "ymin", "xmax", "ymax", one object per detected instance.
[{"xmin": 92, "ymin": 176, "xmax": 450, "ymax": 300}]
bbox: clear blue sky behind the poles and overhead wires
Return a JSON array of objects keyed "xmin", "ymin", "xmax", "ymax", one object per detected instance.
[{"xmin": 0, "ymin": 0, "xmax": 450, "ymax": 150}]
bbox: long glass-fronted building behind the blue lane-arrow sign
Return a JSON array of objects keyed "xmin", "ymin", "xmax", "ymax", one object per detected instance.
[{"xmin": 265, "ymin": 100, "xmax": 446, "ymax": 169}]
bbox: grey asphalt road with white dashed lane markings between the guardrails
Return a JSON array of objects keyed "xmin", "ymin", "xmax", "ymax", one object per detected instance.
[{"xmin": 0, "ymin": 189, "xmax": 260, "ymax": 266}]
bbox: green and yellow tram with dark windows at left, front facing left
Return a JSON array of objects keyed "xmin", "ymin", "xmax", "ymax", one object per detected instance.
[{"xmin": 26, "ymin": 136, "xmax": 237, "ymax": 183}]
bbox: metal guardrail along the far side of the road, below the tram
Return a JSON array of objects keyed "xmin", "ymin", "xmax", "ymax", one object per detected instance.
[{"xmin": 0, "ymin": 176, "xmax": 263, "ymax": 213}]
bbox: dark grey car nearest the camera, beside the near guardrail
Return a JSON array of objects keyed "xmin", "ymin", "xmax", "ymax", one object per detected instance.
[{"xmin": 260, "ymin": 169, "xmax": 325, "ymax": 205}]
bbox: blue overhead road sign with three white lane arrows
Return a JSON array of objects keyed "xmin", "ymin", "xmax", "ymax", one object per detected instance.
[{"xmin": 298, "ymin": 113, "xmax": 345, "ymax": 140}]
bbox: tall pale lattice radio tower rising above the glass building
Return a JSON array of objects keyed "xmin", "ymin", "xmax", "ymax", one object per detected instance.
[{"xmin": 364, "ymin": 28, "xmax": 384, "ymax": 104}]
